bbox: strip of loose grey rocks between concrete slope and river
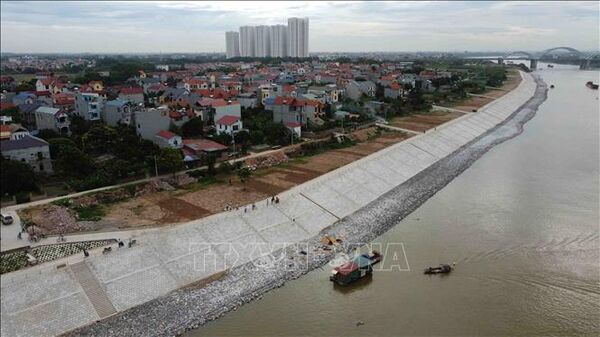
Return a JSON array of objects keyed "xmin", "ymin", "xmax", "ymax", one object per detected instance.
[{"xmin": 65, "ymin": 75, "xmax": 548, "ymax": 336}]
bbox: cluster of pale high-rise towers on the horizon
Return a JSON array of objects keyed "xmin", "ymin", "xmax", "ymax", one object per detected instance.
[{"xmin": 225, "ymin": 18, "xmax": 308, "ymax": 58}]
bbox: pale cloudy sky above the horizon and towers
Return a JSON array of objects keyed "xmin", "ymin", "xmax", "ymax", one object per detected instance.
[{"xmin": 0, "ymin": 0, "xmax": 600, "ymax": 53}]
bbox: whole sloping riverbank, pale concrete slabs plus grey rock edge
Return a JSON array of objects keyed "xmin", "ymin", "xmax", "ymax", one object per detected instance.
[{"xmin": 2, "ymin": 74, "xmax": 541, "ymax": 336}]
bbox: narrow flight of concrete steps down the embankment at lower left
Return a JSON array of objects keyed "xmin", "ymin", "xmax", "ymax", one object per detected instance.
[{"xmin": 69, "ymin": 262, "xmax": 117, "ymax": 318}]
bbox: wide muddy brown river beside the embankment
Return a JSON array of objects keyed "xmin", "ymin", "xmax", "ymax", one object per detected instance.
[{"xmin": 187, "ymin": 63, "xmax": 600, "ymax": 337}]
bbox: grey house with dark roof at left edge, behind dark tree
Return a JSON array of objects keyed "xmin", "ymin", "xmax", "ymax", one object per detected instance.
[{"xmin": 0, "ymin": 135, "xmax": 52, "ymax": 174}]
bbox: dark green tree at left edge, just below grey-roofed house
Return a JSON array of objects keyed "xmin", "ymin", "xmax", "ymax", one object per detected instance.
[{"xmin": 0, "ymin": 157, "xmax": 38, "ymax": 195}]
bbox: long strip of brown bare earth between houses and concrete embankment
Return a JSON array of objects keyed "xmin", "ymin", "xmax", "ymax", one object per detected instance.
[{"xmin": 21, "ymin": 127, "xmax": 410, "ymax": 234}]
